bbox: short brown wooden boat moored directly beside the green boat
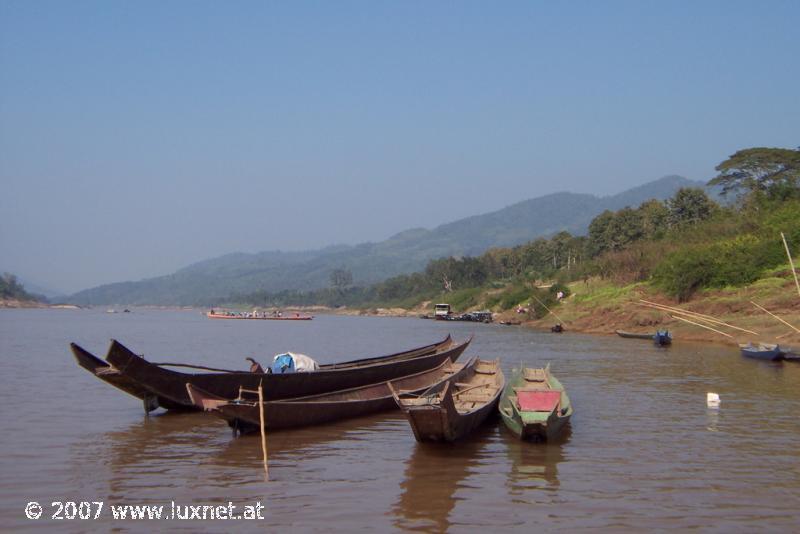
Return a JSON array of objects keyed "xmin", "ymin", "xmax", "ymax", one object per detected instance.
[{"xmin": 393, "ymin": 360, "xmax": 505, "ymax": 442}]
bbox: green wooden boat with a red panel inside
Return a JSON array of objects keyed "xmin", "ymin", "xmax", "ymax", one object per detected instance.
[{"xmin": 499, "ymin": 365, "xmax": 572, "ymax": 441}]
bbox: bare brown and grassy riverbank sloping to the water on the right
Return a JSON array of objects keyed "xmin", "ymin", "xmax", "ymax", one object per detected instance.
[{"xmin": 340, "ymin": 266, "xmax": 800, "ymax": 347}]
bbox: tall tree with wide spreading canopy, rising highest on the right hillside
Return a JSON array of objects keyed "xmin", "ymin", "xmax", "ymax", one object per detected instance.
[{"xmin": 708, "ymin": 147, "xmax": 800, "ymax": 198}]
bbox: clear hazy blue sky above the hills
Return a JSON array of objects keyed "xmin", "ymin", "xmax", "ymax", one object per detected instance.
[{"xmin": 0, "ymin": 0, "xmax": 800, "ymax": 292}]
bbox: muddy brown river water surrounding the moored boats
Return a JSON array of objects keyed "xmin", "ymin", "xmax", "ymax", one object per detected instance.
[{"xmin": 0, "ymin": 309, "xmax": 800, "ymax": 532}]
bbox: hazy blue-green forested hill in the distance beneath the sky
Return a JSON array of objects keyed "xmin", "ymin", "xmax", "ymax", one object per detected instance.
[{"xmin": 68, "ymin": 176, "xmax": 703, "ymax": 305}]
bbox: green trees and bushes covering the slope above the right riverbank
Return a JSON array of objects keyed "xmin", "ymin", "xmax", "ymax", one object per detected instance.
[{"xmin": 229, "ymin": 149, "xmax": 800, "ymax": 330}]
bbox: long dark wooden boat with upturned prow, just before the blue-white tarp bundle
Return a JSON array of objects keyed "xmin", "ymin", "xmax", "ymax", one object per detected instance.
[{"xmin": 106, "ymin": 336, "xmax": 472, "ymax": 409}]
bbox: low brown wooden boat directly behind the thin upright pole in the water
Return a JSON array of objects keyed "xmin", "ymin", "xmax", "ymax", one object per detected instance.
[{"xmin": 186, "ymin": 358, "xmax": 477, "ymax": 433}]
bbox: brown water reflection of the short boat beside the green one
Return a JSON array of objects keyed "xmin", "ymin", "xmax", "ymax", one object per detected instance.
[{"xmin": 393, "ymin": 425, "xmax": 496, "ymax": 532}]
